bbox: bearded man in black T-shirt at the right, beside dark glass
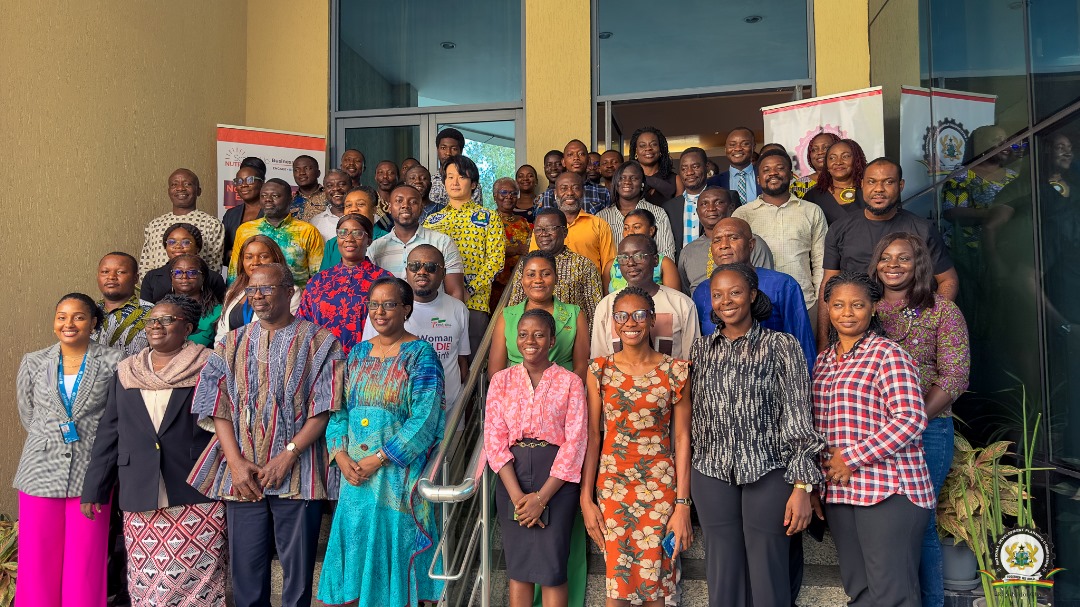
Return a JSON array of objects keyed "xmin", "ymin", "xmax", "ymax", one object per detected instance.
[{"xmin": 818, "ymin": 158, "xmax": 960, "ymax": 348}]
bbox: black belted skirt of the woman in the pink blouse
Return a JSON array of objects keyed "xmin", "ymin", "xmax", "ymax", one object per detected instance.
[{"xmin": 495, "ymin": 440, "xmax": 581, "ymax": 586}]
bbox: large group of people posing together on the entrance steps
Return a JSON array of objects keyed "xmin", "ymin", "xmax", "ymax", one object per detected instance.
[{"xmin": 15, "ymin": 121, "xmax": 969, "ymax": 607}]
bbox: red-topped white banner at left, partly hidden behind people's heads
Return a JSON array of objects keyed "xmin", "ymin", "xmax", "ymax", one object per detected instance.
[{"xmin": 217, "ymin": 124, "xmax": 326, "ymax": 217}]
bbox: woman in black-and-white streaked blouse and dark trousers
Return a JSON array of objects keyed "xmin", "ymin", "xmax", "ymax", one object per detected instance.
[{"xmin": 690, "ymin": 264, "xmax": 825, "ymax": 607}]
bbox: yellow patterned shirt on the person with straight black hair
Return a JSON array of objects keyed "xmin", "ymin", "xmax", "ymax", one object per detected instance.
[{"xmin": 423, "ymin": 201, "xmax": 507, "ymax": 312}]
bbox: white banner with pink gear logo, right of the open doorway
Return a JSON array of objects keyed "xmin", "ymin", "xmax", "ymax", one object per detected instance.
[{"xmin": 761, "ymin": 86, "xmax": 885, "ymax": 176}]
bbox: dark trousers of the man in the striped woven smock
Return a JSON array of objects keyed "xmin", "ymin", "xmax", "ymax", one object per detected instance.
[{"xmin": 225, "ymin": 496, "xmax": 323, "ymax": 607}]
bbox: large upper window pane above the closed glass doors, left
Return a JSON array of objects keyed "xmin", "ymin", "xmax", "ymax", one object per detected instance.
[{"xmin": 336, "ymin": 0, "xmax": 522, "ymax": 110}]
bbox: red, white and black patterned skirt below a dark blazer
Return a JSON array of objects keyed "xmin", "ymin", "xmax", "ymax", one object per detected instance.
[{"xmin": 124, "ymin": 501, "xmax": 229, "ymax": 607}]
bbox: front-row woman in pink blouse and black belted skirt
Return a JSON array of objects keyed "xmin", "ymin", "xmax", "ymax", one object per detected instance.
[{"xmin": 484, "ymin": 308, "xmax": 588, "ymax": 607}]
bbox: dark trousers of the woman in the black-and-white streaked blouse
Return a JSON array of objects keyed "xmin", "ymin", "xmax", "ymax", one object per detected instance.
[{"xmin": 690, "ymin": 470, "xmax": 792, "ymax": 607}]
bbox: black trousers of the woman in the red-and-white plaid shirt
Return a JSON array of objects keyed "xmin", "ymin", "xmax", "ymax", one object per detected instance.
[{"xmin": 825, "ymin": 495, "xmax": 930, "ymax": 607}]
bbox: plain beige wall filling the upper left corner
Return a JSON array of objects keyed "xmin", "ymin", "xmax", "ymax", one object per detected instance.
[{"xmin": 0, "ymin": 0, "xmax": 247, "ymax": 514}]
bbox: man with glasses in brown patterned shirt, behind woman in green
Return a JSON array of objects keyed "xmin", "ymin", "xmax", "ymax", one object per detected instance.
[{"xmin": 507, "ymin": 208, "xmax": 604, "ymax": 327}]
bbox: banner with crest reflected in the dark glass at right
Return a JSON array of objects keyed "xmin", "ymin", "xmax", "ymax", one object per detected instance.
[{"xmin": 900, "ymin": 86, "xmax": 997, "ymax": 194}]
